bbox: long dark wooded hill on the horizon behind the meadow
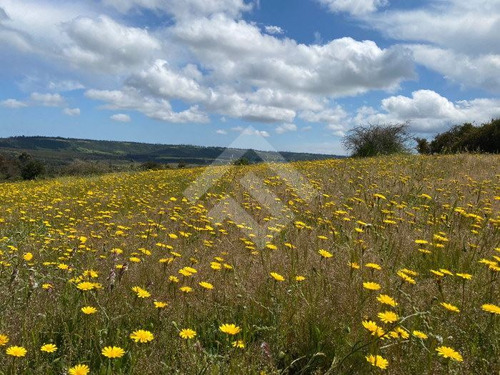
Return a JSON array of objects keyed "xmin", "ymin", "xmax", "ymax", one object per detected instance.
[{"xmin": 0, "ymin": 136, "xmax": 341, "ymax": 167}]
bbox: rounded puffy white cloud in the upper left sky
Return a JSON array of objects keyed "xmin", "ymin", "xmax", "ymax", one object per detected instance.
[{"xmin": 63, "ymin": 16, "xmax": 161, "ymax": 73}]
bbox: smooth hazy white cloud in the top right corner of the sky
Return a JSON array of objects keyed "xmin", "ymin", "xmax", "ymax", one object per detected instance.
[{"xmin": 364, "ymin": 0, "xmax": 500, "ymax": 92}]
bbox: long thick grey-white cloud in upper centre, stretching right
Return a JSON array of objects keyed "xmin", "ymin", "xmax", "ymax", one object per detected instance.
[{"xmin": 173, "ymin": 15, "xmax": 414, "ymax": 97}]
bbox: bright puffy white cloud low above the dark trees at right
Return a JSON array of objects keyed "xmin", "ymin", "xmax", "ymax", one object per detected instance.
[{"xmin": 353, "ymin": 90, "xmax": 500, "ymax": 133}]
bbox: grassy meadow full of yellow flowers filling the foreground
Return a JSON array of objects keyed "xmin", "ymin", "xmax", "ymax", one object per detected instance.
[{"xmin": 0, "ymin": 155, "xmax": 500, "ymax": 375}]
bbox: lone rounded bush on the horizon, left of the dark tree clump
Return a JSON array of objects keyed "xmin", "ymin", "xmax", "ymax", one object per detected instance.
[{"xmin": 342, "ymin": 123, "xmax": 411, "ymax": 157}]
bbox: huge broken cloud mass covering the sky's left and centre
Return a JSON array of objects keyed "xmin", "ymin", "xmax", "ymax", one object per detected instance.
[{"xmin": 0, "ymin": 0, "xmax": 414, "ymax": 124}]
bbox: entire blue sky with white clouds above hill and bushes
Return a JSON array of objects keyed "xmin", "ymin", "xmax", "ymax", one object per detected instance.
[{"xmin": 0, "ymin": 0, "xmax": 500, "ymax": 155}]
